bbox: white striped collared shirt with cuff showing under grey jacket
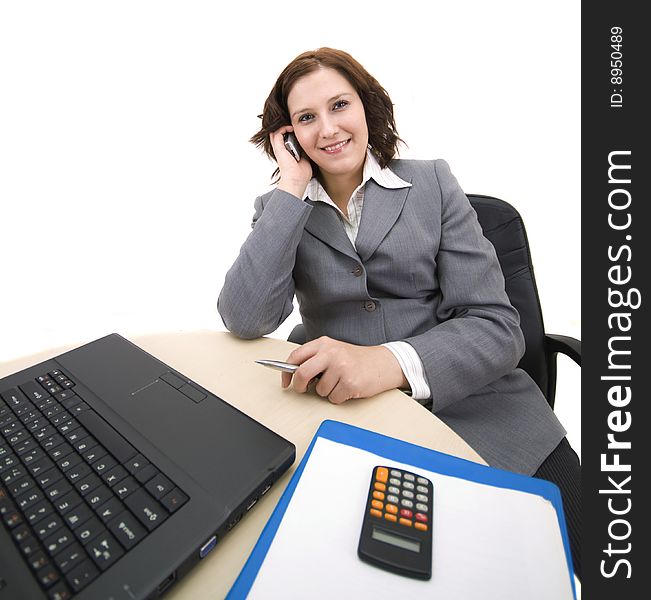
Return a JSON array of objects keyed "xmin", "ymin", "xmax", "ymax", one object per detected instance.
[{"xmin": 303, "ymin": 150, "xmax": 432, "ymax": 401}]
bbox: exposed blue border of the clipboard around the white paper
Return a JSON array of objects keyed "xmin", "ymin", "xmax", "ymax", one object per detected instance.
[{"xmin": 226, "ymin": 420, "xmax": 576, "ymax": 600}]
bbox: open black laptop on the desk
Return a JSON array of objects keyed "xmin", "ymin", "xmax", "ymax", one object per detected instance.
[{"xmin": 0, "ymin": 334, "xmax": 296, "ymax": 600}]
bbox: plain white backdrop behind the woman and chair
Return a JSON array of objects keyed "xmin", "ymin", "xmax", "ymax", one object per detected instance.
[{"xmin": 0, "ymin": 0, "xmax": 581, "ymax": 452}]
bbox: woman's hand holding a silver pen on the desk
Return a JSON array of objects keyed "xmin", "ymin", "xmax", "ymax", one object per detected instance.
[{"xmin": 282, "ymin": 337, "xmax": 407, "ymax": 404}]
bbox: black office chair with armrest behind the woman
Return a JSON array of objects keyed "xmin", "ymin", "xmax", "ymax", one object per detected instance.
[{"xmin": 288, "ymin": 194, "xmax": 581, "ymax": 409}]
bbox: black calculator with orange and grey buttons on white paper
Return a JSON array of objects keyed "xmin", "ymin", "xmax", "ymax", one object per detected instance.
[{"xmin": 357, "ymin": 466, "xmax": 433, "ymax": 579}]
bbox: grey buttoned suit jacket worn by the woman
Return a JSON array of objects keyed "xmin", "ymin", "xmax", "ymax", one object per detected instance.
[{"xmin": 218, "ymin": 160, "xmax": 565, "ymax": 475}]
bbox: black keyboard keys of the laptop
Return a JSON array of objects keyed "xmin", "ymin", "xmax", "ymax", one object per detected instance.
[{"xmin": 0, "ymin": 370, "xmax": 188, "ymax": 600}]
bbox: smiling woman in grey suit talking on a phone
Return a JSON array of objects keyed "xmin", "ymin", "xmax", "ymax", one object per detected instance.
[{"xmin": 218, "ymin": 48, "xmax": 580, "ymax": 575}]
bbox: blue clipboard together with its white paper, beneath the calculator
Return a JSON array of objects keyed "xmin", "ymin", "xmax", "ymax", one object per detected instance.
[{"xmin": 227, "ymin": 421, "xmax": 575, "ymax": 600}]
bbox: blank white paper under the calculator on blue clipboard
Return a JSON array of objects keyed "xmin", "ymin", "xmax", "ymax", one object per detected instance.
[{"xmin": 249, "ymin": 438, "xmax": 573, "ymax": 600}]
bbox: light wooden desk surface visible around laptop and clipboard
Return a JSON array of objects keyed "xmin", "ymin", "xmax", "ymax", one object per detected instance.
[{"xmin": 0, "ymin": 331, "xmax": 485, "ymax": 600}]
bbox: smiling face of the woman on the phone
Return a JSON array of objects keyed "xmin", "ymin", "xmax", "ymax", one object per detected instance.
[{"xmin": 287, "ymin": 68, "xmax": 368, "ymax": 177}]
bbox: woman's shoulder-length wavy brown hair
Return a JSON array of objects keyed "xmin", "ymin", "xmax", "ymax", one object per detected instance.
[{"xmin": 249, "ymin": 48, "xmax": 402, "ymax": 176}]
